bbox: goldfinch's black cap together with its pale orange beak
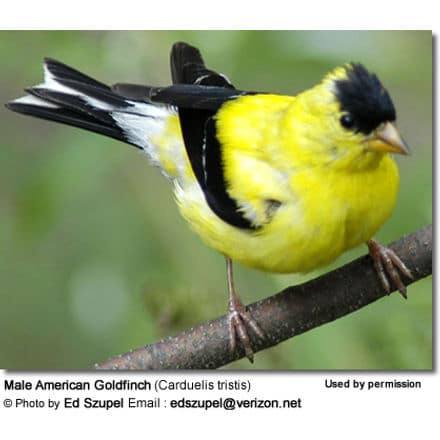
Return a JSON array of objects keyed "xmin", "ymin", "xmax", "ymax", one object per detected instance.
[{"xmin": 334, "ymin": 63, "xmax": 409, "ymax": 154}]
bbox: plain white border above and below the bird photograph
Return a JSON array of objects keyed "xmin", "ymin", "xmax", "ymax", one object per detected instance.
[{"xmin": 0, "ymin": 0, "xmax": 439, "ymax": 440}]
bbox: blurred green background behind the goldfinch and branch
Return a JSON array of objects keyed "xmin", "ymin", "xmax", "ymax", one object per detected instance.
[{"xmin": 0, "ymin": 31, "xmax": 433, "ymax": 370}]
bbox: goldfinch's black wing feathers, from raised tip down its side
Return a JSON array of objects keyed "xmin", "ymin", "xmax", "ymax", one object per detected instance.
[{"xmin": 158, "ymin": 43, "xmax": 255, "ymax": 229}]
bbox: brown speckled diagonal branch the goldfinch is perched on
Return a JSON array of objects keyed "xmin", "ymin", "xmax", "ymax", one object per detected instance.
[{"xmin": 95, "ymin": 226, "xmax": 432, "ymax": 370}]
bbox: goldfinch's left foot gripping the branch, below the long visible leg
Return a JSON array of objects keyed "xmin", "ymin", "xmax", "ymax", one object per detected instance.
[{"xmin": 228, "ymin": 297, "xmax": 265, "ymax": 362}]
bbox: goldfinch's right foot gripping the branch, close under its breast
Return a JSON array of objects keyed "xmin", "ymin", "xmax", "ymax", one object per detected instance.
[{"xmin": 367, "ymin": 240, "xmax": 414, "ymax": 299}]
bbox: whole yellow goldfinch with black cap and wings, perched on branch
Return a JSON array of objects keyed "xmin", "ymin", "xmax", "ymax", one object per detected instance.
[{"xmin": 8, "ymin": 42, "xmax": 411, "ymax": 360}]
